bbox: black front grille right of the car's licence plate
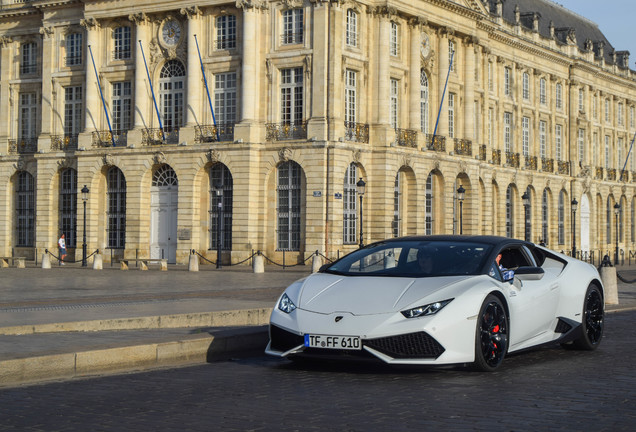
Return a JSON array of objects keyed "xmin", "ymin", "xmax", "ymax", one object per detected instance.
[{"xmin": 363, "ymin": 332, "xmax": 445, "ymax": 359}]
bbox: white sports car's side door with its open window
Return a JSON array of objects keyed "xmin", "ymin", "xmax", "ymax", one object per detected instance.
[{"xmin": 502, "ymin": 245, "xmax": 559, "ymax": 349}]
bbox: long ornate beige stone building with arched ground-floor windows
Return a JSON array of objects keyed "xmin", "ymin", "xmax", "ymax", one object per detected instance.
[{"xmin": 0, "ymin": 0, "xmax": 636, "ymax": 264}]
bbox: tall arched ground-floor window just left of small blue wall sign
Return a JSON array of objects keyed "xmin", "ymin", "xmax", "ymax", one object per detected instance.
[{"xmin": 277, "ymin": 161, "xmax": 302, "ymax": 251}]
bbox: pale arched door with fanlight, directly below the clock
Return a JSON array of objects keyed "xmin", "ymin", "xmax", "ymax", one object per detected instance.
[{"xmin": 150, "ymin": 165, "xmax": 179, "ymax": 263}]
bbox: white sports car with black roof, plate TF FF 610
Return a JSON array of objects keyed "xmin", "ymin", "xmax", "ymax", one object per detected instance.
[{"xmin": 265, "ymin": 236, "xmax": 604, "ymax": 371}]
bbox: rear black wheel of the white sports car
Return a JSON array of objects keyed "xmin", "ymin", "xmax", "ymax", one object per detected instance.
[{"xmin": 572, "ymin": 283, "xmax": 605, "ymax": 351}]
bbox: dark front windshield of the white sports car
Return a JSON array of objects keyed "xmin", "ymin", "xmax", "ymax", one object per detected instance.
[{"xmin": 324, "ymin": 240, "xmax": 492, "ymax": 277}]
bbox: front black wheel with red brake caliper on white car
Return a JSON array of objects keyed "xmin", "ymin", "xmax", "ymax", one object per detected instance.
[{"xmin": 473, "ymin": 295, "xmax": 508, "ymax": 372}]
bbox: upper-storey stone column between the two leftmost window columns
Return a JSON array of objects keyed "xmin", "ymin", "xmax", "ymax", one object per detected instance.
[{"xmin": 38, "ymin": 27, "xmax": 58, "ymax": 152}]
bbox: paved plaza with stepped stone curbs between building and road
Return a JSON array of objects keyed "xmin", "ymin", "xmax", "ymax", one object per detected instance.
[{"xmin": 0, "ymin": 266, "xmax": 636, "ymax": 387}]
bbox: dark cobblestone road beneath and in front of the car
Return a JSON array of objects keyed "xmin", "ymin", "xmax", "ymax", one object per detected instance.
[{"xmin": 0, "ymin": 311, "xmax": 636, "ymax": 432}]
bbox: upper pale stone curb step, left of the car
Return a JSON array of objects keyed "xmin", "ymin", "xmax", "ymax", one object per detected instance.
[{"xmin": 0, "ymin": 308, "xmax": 272, "ymax": 336}]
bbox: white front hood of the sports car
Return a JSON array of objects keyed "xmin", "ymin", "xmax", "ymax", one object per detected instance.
[{"xmin": 298, "ymin": 273, "xmax": 472, "ymax": 315}]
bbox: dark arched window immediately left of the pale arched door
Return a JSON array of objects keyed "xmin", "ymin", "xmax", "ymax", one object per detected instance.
[{"xmin": 106, "ymin": 167, "xmax": 126, "ymax": 249}]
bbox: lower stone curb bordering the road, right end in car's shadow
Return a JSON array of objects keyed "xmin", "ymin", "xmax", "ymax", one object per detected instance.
[{"xmin": 0, "ymin": 326, "xmax": 269, "ymax": 388}]
